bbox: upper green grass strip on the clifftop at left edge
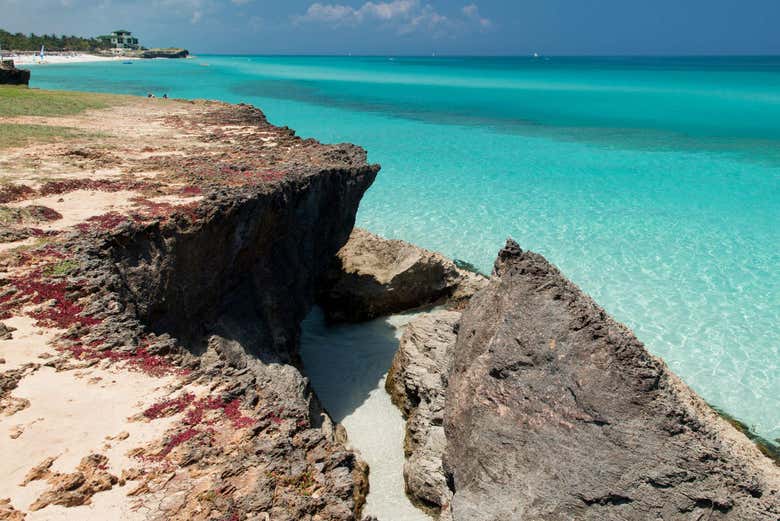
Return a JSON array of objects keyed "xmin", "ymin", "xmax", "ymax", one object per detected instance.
[{"xmin": 0, "ymin": 86, "xmax": 128, "ymax": 117}]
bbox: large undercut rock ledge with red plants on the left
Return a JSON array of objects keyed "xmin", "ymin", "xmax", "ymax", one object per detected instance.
[{"xmin": 0, "ymin": 100, "xmax": 379, "ymax": 521}]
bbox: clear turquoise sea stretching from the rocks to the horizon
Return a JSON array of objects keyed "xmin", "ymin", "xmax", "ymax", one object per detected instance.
[{"xmin": 27, "ymin": 56, "xmax": 780, "ymax": 439}]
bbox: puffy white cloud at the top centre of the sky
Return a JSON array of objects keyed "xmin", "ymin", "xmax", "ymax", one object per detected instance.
[{"xmin": 293, "ymin": 0, "xmax": 491, "ymax": 34}]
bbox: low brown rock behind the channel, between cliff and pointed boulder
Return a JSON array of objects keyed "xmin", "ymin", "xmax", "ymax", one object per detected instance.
[{"xmin": 320, "ymin": 229, "xmax": 486, "ymax": 321}]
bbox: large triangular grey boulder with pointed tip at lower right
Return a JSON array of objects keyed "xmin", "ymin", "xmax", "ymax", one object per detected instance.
[{"xmin": 445, "ymin": 241, "xmax": 780, "ymax": 521}]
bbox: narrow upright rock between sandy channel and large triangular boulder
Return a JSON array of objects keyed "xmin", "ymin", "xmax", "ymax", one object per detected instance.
[{"xmin": 386, "ymin": 311, "xmax": 460, "ymax": 513}]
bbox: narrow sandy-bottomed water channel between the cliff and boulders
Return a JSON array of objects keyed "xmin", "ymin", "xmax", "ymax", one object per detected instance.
[{"xmin": 301, "ymin": 309, "xmax": 431, "ymax": 521}]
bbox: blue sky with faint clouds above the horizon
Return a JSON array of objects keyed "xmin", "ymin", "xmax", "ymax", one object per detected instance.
[{"xmin": 0, "ymin": 0, "xmax": 780, "ymax": 55}]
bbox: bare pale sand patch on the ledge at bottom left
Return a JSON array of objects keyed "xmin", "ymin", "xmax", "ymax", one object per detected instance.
[{"xmin": 0, "ymin": 317, "xmax": 183, "ymax": 521}]
